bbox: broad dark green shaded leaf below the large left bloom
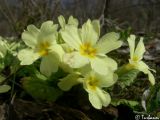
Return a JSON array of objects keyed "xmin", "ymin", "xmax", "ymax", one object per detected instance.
[{"xmin": 23, "ymin": 77, "xmax": 62, "ymax": 101}]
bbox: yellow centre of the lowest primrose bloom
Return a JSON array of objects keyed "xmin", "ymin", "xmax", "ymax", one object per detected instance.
[{"xmin": 86, "ymin": 76, "xmax": 99, "ymax": 90}]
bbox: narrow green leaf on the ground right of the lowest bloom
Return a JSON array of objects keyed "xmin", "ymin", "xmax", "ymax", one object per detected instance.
[{"xmin": 111, "ymin": 99, "xmax": 139, "ymax": 108}]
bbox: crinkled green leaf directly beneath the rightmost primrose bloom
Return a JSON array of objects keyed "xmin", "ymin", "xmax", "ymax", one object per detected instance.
[{"xmin": 116, "ymin": 65, "xmax": 139, "ymax": 88}]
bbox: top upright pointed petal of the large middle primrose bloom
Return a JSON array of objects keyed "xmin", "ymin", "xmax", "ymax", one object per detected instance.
[{"xmin": 81, "ymin": 20, "xmax": 99, "ymax": 45}]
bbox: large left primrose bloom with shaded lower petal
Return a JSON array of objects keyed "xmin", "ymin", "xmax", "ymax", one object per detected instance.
[{"xmin": 18, "ymin": 21, "xmax": 64, "ymax": 76}]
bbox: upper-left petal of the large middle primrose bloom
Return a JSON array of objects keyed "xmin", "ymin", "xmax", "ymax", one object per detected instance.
[{"xmin": 61, "ymin": 26, "xmax": 81, "ymax": 50}]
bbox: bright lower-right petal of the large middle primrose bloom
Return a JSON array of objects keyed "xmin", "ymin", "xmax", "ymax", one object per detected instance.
[{"xmin": 91, "ymin": 57, "xmax": 108, "ymax": 75}]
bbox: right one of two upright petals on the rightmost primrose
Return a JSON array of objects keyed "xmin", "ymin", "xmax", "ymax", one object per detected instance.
[{"xmin": 134, "ymin": 38, "xmax": 145, "ymax": 60}]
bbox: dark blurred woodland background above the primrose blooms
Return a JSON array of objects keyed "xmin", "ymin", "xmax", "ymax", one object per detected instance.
[{"xmin": 0, "ymin": 0, "xmax": 160, "ymax": 37}]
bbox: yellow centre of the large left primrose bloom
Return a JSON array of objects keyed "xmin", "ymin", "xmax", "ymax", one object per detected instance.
[{"xmin": 37, "ymin": 41, "xmax": 50, "ymax": 56}]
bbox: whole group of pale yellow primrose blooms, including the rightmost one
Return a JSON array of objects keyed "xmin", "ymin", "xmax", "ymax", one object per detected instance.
[{"xmin": 15, "ymin": 16, "xmax": 155, "ymax": 109}]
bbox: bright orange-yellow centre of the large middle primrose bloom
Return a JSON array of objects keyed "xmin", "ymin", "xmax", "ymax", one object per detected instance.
[{"xmin": 80, "ymin": 43, "xmax": 97, "ymax": 58}]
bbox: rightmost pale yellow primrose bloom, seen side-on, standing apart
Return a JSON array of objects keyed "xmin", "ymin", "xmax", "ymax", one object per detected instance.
[{"xmin": 127, "ymin": 35, "xmax": 155, "ymax": 85}]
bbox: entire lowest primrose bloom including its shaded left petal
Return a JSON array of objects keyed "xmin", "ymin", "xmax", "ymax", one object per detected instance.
[{"xmin": 58, "ymin": 71, "xmax": 117, "ymax": 109}]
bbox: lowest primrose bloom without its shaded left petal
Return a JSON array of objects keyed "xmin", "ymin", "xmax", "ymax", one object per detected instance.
[{"xmin": 83, "ymin": 72, "xmax": 118, "ymax": 109}]
